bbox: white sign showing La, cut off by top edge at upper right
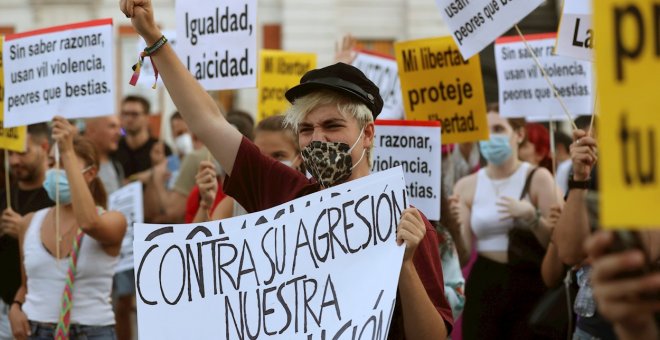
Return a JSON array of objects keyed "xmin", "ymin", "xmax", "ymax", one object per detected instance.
[{"xmin": 555, "ymin": 0, "xmax": 594, "ymax": 61}]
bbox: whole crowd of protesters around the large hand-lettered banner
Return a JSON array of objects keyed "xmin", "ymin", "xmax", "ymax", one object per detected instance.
[{"xmin": 0, "ymin": 0, "xmax": 660, "ymax": 340}]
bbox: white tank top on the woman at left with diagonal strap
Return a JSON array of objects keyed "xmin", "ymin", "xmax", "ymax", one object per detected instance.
[{"xmin": 23, "ymin": 208, "xmax": 119, "ymax": 326}]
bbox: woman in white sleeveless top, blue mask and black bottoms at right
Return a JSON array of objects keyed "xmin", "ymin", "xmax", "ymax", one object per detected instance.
[{"xmin": 450, "ymin": 105, "xmax": 560, "ymax": 340}]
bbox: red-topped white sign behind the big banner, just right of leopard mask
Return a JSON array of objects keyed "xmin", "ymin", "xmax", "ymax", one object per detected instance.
[{"xmin": 371, "ymin": 120, "xmax": 442, "ymax": 221}]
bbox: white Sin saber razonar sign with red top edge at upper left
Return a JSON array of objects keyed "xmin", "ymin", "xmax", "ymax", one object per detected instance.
[{"xmin": 3, "ymin": 19, "xmax": 116, "ymax": 127}]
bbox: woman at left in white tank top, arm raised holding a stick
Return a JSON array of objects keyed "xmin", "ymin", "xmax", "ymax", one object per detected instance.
[{"xmin": 9, "ymin": 117, "xmax": 126, "ymax": 340}]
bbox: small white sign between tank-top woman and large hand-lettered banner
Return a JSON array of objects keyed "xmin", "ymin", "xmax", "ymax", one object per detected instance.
[{"xmin": 108, "ymin": 182, "xmax": 144, "ymax": 273}]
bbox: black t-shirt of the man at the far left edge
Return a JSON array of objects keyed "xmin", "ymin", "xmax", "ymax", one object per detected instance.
[{"xmin": 0, "ymin": 187, "xmax": 55, "ymax": 304}]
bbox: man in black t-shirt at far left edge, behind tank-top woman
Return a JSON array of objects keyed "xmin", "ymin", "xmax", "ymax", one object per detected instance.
[{"xmin": 0, "ymin": 123, "xmax": 54, "ymax": 340}]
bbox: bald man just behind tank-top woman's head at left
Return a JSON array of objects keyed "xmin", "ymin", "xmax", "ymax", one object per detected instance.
[{"xmin": 85, "ymin": 115, "xmax": 124, "ymax": 195}]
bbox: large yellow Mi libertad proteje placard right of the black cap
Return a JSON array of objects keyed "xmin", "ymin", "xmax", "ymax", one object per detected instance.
[{"xmin": 394, "ymin": 37, "xmax": 488, "ymax": 144}]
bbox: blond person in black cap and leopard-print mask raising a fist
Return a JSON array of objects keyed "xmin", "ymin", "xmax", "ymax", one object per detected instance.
[{"xmin": 120, "ymin": 0, "xmax": 453, "ymax": 340}]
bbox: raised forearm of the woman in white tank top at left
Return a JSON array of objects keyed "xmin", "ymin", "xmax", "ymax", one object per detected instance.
[{"xmin": 61, "ymin": 150, "xmax": 101, "ymax": 234}]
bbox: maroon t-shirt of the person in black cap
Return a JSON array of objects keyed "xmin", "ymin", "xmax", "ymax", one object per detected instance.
[{"xmin": 224, "ymin": 137, "xmax": 454, "ymax": 339}]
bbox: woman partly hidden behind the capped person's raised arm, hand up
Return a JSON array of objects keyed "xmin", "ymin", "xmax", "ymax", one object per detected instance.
[{"xmin": 195, "ymin": 115, "xmax": 302, "ymax": 222}]
